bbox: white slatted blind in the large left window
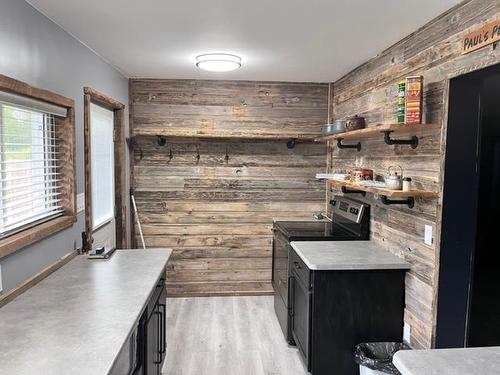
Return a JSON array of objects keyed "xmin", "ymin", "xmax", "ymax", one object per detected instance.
[{"xmin": 0, "ymin": 101, "xmax": 65, "ymax": 238}]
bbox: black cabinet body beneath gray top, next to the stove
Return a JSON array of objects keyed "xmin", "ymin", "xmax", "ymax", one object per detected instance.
[{"xmin": 289, "ymin": 250, "xmax": 406, "ymax": 375}]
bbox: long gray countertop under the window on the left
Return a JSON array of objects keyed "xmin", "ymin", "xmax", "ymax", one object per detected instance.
[{"xmin": 0, "ymin": 249, "xmax": 172, "ymax": 375}]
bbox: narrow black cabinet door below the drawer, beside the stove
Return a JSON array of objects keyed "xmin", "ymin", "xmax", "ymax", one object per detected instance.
[{"xmin": 290, "ymin": 269, "xmax": 311, "ymax": 371}]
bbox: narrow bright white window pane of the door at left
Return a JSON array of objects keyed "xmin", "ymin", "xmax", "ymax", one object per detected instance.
[{"xmin": 90, "ymin": 103, "xmax": 115, "ymax": 229}]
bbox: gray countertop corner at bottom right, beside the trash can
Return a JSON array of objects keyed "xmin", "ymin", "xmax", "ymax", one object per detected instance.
[{"xmin": 392, "ymin": 346, "xmax": 500, "ymax": 375}]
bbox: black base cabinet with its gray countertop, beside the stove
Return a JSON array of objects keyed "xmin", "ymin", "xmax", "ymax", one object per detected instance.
[{"xmin": 289, "ymin": 241, "xmax": 409, "ymax": 375}]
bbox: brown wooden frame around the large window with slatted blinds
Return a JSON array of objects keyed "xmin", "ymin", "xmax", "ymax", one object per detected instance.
[{"xmin": 0, "ymin": 74, "xmax": 77, "ymax": 259}]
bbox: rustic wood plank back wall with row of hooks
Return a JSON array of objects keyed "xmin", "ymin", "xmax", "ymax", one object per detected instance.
[{"xmin": 130, "ymin": 80, "xmax": 328, "ymax": 296}]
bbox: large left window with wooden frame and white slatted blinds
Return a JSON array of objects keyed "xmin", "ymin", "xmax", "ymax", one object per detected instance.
[{"xmin": 0, "ymin": 75, "xmax": 76, "ymax": 258}]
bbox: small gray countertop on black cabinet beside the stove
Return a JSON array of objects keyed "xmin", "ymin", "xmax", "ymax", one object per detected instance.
[{"xmin": 291, "ymin": 241, "xmax": 410, "ymax": 271}]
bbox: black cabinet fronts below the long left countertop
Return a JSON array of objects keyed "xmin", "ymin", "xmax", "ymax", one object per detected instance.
[{"xmin": 109, "ymin": 277, "xmax": 167, "ymax": 375}]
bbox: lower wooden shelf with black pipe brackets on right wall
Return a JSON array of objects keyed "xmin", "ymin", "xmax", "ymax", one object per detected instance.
[{"xmin": 326, "ymin": 180, "xmax": 438, "ymax": 208}]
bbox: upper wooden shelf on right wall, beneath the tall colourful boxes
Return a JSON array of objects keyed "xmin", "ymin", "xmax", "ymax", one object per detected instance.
[{"xmin": 316, "ymin": 124, "xmax": 441, "ymax": 142}]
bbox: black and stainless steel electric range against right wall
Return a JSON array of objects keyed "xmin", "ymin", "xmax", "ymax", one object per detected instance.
[{"xmin": 272, "ymin": 196, "xmax": 370, "ymax": 344}]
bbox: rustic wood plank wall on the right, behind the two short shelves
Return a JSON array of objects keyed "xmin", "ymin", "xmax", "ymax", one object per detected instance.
[{"xmin": 329, "ymin": 0, "xmax": 500, "ymax": 348}]
